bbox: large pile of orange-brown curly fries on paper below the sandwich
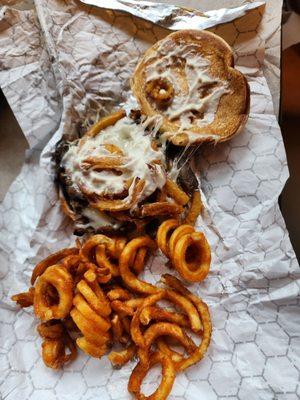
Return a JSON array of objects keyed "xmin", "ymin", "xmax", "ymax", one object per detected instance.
[{"xmin": 12, "ymin": 230, "xmax": 211, "ymax": 400}]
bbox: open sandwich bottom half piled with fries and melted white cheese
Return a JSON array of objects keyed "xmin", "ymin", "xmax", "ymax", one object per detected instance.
[{"xmin": 56, "ymin": 111, "xmax": 200, "ymax": 235}]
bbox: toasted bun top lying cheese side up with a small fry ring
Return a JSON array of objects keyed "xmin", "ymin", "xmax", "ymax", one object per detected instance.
[{"xmin": 131, "ymin": 30, "xmax": 249, "ymax": 146}]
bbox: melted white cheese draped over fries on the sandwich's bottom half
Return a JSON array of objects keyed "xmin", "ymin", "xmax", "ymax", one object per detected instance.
[{"xmin": 62, "ymin": 117, "xmax": 166, "ymax": 201}]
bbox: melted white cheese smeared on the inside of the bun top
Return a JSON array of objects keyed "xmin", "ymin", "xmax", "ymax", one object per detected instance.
[{"xmin": 145, "ymin": 42, "xmax": 229, "ymax": 134}]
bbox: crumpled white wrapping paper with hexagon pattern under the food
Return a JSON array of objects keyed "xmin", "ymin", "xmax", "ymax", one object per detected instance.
[{"xmin": 0, "ymin": 0, "xmax": 300, "ymax": 400}]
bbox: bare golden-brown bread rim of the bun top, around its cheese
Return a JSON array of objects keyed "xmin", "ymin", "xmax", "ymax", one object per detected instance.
[{"xmin": 131, "ymin": 30, "xmax": 250, "ymax": 146}]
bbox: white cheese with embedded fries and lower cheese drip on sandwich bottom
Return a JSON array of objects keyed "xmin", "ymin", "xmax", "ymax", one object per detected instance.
[{"xmin": 61, "ymin": 117, "xmax": 167, "ymax": 230}]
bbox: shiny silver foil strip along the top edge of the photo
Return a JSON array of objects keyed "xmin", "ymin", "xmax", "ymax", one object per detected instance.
[{"xmin": 80, "ymin": 0, "xmax": 265, "ymax": 31}]
